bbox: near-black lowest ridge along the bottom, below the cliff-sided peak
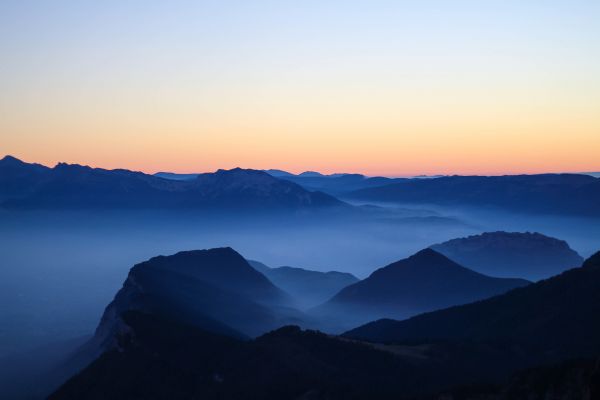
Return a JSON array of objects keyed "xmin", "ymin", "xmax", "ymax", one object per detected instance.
[{"xmin": 49, "ymin": 312, "xmax": 492, "ymax": 400}]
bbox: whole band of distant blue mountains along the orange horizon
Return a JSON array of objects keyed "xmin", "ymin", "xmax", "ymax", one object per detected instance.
[{"xmin": 5, "ymin": 156, "xmax": 600, "ymax": 216}]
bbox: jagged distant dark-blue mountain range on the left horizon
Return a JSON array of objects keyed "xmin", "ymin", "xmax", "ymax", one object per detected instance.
[{"xmin": 0, "ymin": 158, "xmax": 348, "ymax": 210}]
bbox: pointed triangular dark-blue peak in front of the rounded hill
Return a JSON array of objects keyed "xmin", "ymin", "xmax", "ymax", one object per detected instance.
[{"xmin": 311, "ymin": 249, "xmax": 529, "ymax": 332}]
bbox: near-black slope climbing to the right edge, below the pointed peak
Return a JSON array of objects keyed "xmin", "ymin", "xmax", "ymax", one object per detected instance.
[{"xmin": 346, "ymin": 252, "xmax": 600, "ymax": 362}]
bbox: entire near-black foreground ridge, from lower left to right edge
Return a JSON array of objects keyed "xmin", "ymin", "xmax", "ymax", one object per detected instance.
[{"xmin": 50, "ymin": 250, "xmax": 600, "ymax": 400}]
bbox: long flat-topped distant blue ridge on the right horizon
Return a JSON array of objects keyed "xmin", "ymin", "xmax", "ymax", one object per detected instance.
[{"xmin": 348, "ymin": 174, "xmax": 600, "ymax": 216}]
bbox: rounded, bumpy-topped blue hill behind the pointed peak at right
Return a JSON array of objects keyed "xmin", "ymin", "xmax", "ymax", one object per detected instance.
[{"xmin": 431, "ymin": 232, "xmax": 583, "ymax": 280}]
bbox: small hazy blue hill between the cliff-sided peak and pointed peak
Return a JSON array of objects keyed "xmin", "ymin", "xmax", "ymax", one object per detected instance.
[{"xmin": 248, "ymin": 260, "xmax": 358, "ymax": 309}]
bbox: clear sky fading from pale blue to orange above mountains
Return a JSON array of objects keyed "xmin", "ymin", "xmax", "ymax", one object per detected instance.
[{"xmin": 0, "ymin": 0, "xmax": 600, "ymax": 175}]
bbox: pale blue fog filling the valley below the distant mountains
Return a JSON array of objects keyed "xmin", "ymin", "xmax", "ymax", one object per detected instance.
[{"xmin": 0, "ymin": 206, "xmax": 600, "ymax": 357}]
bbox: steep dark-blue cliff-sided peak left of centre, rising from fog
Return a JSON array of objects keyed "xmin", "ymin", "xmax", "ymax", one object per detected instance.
[{"xmin": 94, "ymin": 248, "xmax": 302, "ymax": 348}]
